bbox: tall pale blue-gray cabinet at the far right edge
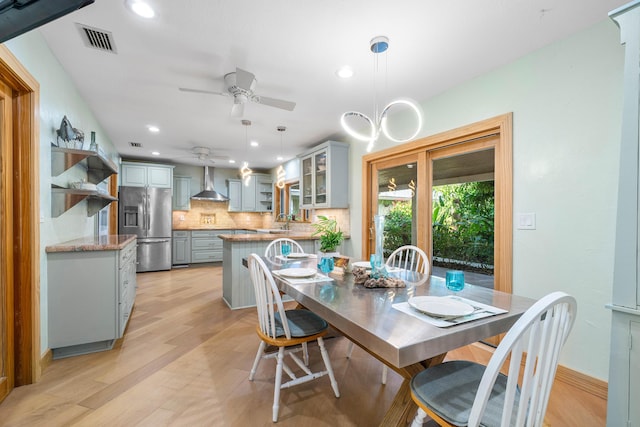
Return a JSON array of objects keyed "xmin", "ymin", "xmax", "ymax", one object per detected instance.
[{"xmin": 607, "ymin": 1, "xmax": 640, "ymax": 427}]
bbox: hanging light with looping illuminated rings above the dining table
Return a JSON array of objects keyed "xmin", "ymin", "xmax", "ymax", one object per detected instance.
[{"xmin": 340, "ymin": 36, "xmax": 422, "ymax": 152}]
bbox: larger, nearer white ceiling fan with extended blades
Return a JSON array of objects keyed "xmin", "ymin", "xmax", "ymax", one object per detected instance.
[{"xmin": 179, "ymin": 67, "xmax": 296, "ymax": 117}]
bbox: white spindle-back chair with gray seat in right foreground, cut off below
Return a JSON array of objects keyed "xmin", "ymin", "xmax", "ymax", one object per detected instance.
[{"xmin": 410, "ymin": 292, "xmax": 576, "ymax": 427}]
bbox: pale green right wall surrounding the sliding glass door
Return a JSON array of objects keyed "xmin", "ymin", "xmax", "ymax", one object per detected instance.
[{"xmin": 350, "ymin": 19, "xmax": 623, "ymax": 380}]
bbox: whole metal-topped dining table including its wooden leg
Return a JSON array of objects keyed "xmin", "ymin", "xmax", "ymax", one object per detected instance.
[{"xmin": 263, "ymin": 255, "xmax": 535, "ymax": 427}]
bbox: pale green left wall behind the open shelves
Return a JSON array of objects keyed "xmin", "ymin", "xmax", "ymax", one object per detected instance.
[{"xmin": 5, "ymin": 30, "xmax": 118, "ymax": 352}]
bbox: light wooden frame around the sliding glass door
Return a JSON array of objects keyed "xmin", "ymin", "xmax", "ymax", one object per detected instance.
[{"xmin": 362, "ymin": 113, "xmax": 513, "ymax": 293}]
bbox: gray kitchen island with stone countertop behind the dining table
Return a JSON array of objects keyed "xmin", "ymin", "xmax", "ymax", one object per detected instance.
[{"xmin": 219, "ymin": 231, "xmax": 319, "ymax": 310}]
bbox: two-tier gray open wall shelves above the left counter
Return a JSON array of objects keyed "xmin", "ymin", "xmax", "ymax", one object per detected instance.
[{"xmin": 51, "ymin": 145, "xmax": 118, "ymax": 218}]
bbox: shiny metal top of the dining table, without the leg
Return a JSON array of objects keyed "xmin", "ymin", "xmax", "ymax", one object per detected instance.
[{"xmin": 266, "ymin": 258, "xmax": 535, "ymax": 368}]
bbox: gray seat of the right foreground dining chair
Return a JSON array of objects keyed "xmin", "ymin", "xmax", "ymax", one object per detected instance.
[{"xmin": 411, "ymin": 360, "xmax": 520, "ymax": 427}]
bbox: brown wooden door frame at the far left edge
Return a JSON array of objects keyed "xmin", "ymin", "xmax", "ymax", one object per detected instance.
[{"xmin": 0, "ymin": 45, "xmax": 41, "ymax": 386}]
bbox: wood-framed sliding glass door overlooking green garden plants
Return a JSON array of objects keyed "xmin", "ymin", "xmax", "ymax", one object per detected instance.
[{"xmin": 362, "ymin": 114, "xmax": 512, "ymax": 298}]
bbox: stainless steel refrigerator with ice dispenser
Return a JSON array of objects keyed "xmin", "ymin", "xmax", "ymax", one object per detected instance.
[{"xmin": 118, "ymin": 187, "xmax": 172, "ymax": 273}]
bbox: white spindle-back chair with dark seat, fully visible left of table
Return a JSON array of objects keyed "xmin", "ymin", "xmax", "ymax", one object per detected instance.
[{"xmin": 249, "ymin": 254, "xmax": 340, "ymax": 422}]
